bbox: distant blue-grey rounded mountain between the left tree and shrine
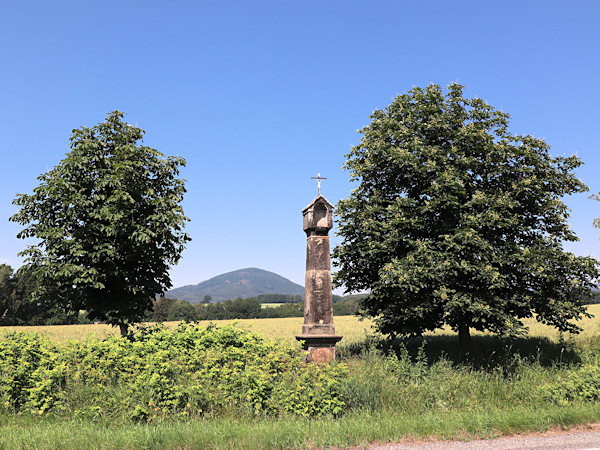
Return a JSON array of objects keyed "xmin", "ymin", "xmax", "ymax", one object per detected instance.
[{"xmin": 165, "ymin": 267, "xmax": 304, "ymax": 303}]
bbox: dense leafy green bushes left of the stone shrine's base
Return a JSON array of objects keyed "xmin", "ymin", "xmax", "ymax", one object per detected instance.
[{"xmin": 0, "ymin": 324, "xmax": 346, "ymax": 421}]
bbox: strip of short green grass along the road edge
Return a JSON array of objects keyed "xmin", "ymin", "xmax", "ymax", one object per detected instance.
[{"xmin": 0, "ymin": 404, "xmax": 600, "ymax": 450}]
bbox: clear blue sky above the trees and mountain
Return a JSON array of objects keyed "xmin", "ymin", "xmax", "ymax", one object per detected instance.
[{"xmin": 0, "ymin": 0, "xmax": 600, "ymax": 287}]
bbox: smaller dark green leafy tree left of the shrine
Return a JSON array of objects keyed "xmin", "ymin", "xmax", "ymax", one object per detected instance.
[{"xmin": 11, "ymin": 111, "xmax": 190, "ymax": 335}]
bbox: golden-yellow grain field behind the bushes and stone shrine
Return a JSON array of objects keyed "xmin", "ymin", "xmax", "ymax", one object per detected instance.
[{"xmin": 0, "ymin": 305, "xmax": 600, "ymax": 343}]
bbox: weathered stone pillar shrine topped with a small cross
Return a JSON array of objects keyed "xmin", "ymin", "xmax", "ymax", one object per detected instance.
[{"xmin": 296, "ymin": 175, "xmax": 342, "ymax": 364}]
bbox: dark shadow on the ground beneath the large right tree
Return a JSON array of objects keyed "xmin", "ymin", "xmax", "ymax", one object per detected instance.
[{"xmin": 340, "ymin": 334, "xmax": 581, "ymax": 371}]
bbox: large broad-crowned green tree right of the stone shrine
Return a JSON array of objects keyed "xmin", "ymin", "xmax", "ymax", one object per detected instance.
[{"xmin": 333, "ymin": 84, "xmax": 598, "ymax": 350}]
